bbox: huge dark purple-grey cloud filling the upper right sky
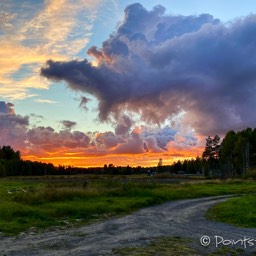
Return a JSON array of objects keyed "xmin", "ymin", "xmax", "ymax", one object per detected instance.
[{"xmin": 41, "ymin": 4, "xmax": 256, "ymax": 136}]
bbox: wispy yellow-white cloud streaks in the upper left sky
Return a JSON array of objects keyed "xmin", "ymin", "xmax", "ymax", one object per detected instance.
[{"xmin": 0, "ymin": 0, "xmax": 105, "ymax": 100}]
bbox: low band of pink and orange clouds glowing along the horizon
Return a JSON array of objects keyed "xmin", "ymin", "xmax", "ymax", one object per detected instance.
[{"xmin": 0, "ymin": 101, "xmax": 201, "ymax": 165}]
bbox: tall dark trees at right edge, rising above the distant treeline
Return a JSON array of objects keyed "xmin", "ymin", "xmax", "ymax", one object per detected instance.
[{"xmin": 171, "ymin": 128, "xmax": 256, "ymax": 177}]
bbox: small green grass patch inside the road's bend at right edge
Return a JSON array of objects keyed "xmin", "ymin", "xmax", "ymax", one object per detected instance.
[{"xmin": 206, "ymin": 195, "xmax": 256, "ymax": 228}]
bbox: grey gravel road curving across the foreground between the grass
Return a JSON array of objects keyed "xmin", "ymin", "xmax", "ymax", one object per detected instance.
[{"xmin": 0, "ymin": 197, "xmax": 256, "ymax": 256}]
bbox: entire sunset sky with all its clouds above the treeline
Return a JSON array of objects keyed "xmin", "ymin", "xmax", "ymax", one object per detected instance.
[{"xmin": 0, "ymin": 0, "xmax": 256, "ymax": 166}]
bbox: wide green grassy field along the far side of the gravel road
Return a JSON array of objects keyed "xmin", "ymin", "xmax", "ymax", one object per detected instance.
[{"xmin": 0, "ymin": 178, "xmax": 256, "ymax": 235}]
